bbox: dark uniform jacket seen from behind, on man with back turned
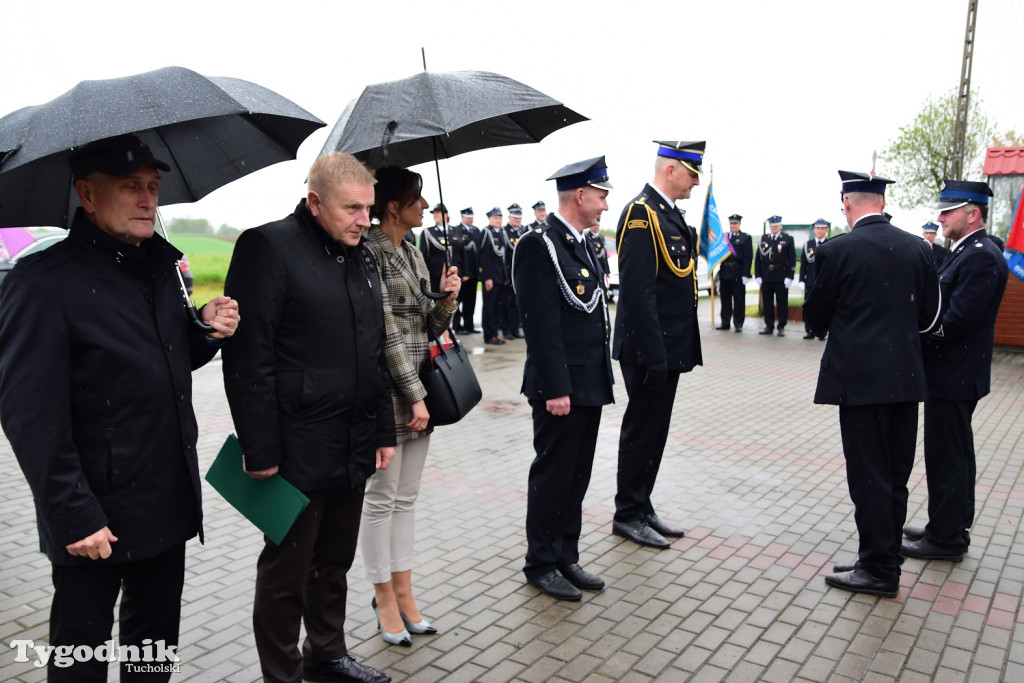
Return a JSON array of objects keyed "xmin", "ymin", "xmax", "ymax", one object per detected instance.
[{"xmin": 804, "ymin": 214, "xmax": 939, "ymax": 405}]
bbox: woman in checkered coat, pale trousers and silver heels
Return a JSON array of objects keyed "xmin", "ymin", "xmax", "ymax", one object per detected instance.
[{"xmin": 359, "ymin": 167, "xmax": 461, "ymax": 646}]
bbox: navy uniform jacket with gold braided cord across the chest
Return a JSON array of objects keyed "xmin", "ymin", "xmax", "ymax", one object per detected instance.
[{"xmin": 612, "ymin": 184, "xmax": 703, "ymax": 372}]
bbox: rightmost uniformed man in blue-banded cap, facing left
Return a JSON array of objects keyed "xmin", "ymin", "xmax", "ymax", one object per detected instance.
[{"xmin": 902, "ymin": 180, "xmax": 1009, "ymax": 562}]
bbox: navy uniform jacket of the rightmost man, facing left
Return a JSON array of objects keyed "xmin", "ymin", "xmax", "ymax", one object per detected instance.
[{"xmin": 924, "ymin": 230, "xmax": 1010, "ymax": 400}]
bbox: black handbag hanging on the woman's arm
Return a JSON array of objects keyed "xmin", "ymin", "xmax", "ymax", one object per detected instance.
[{"xmin": 420, "ymin": 325, "xmax": 483, "ymax": 427}]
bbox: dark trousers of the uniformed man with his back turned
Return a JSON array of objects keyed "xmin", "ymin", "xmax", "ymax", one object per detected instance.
[{"xmin": 839, "ymin": 402, "xmax": 918, "ymax": 580}]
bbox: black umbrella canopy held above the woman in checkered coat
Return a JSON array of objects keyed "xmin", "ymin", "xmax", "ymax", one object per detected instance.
[{"xmin": 321, "ymin": 71, "xmax": 587, "ymax": 168}]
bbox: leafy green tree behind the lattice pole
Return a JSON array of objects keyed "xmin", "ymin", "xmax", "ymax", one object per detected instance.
[{"xmin": 881, "ymin": 90, "xmax": 994, "ymax": 209}]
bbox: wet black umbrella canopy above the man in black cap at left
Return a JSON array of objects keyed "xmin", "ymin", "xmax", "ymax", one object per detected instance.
[{"xmin": 0, "ymin": 67, "xmax": 326, "ymax": 227}]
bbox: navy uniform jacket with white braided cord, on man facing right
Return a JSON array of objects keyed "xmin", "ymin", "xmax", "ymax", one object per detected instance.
[{"xmin": 512, "ymin": 214, "xmax": 614, "ymax": 407}]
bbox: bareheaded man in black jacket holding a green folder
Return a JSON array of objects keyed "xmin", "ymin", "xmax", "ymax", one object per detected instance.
[{"xmin": 223, "ymin": 153, "xmax": 395, "ymax": 683}]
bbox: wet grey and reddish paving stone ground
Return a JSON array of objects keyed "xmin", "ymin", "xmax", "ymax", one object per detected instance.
[{"xmin": 0, "ymin": 299, "xmax": 1024, "ymax": 683}]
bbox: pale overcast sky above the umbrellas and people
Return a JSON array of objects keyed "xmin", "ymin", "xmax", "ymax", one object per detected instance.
[{"xmin": 0, "ymin": 0, "xmax": 1024, "ymax": 232}]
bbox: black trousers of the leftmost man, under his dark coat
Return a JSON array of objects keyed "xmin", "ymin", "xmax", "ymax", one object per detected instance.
[{"xmin": 47, "ymin": 543, "xmax": 185, "ymax": 683}]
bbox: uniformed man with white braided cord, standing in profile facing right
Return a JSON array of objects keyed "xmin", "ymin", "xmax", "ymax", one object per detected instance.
[{"xmin": 512, "ymin": 157, "xmax": 614, "ymax": 600}]
